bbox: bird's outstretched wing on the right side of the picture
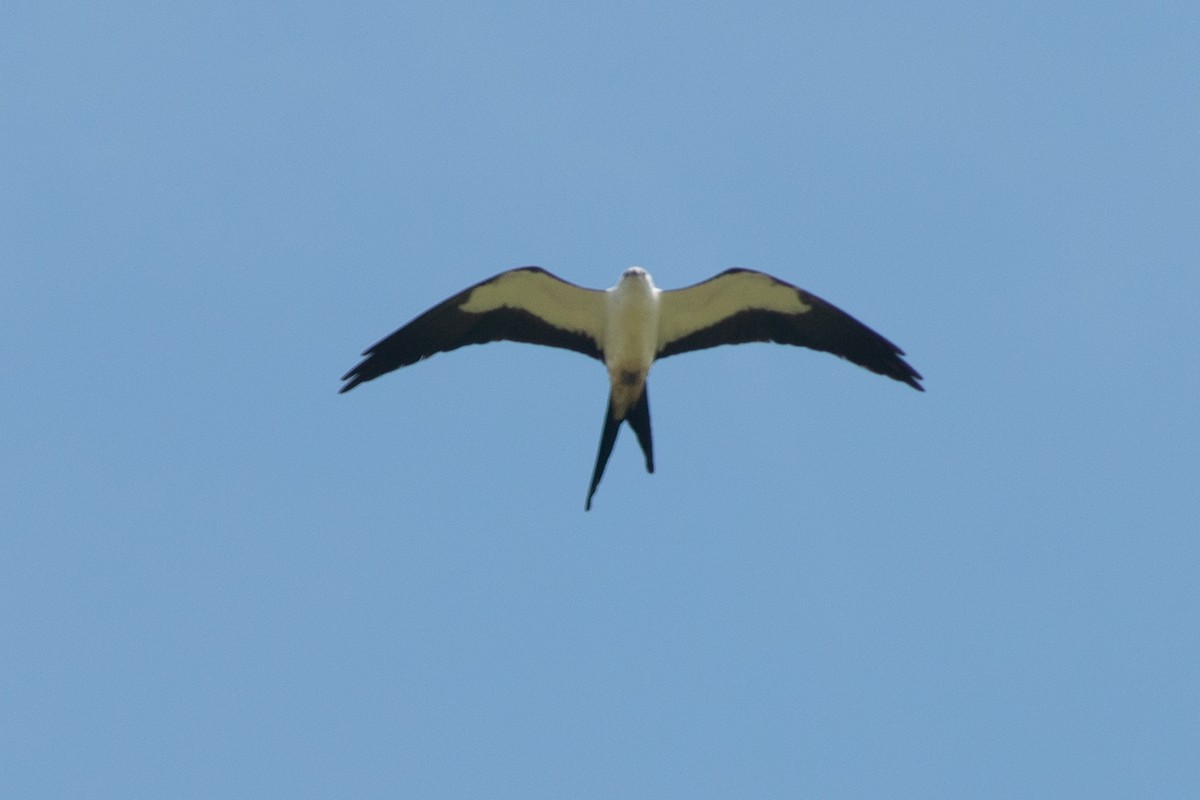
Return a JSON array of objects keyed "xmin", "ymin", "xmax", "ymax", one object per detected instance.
[{"xmin": 658, "ymin": 270, "xmax": 924, "ymax": 391}]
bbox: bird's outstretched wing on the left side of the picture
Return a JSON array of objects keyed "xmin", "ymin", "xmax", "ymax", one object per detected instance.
[{"xmin": 340, "ymin": 266, "xmax": 605, "ymax": 392}]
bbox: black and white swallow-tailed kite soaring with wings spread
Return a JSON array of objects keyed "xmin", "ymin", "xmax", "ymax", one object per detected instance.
[{"xmin": 340, "ymin": 266, "xmax": 925, "ymax": 510}]
